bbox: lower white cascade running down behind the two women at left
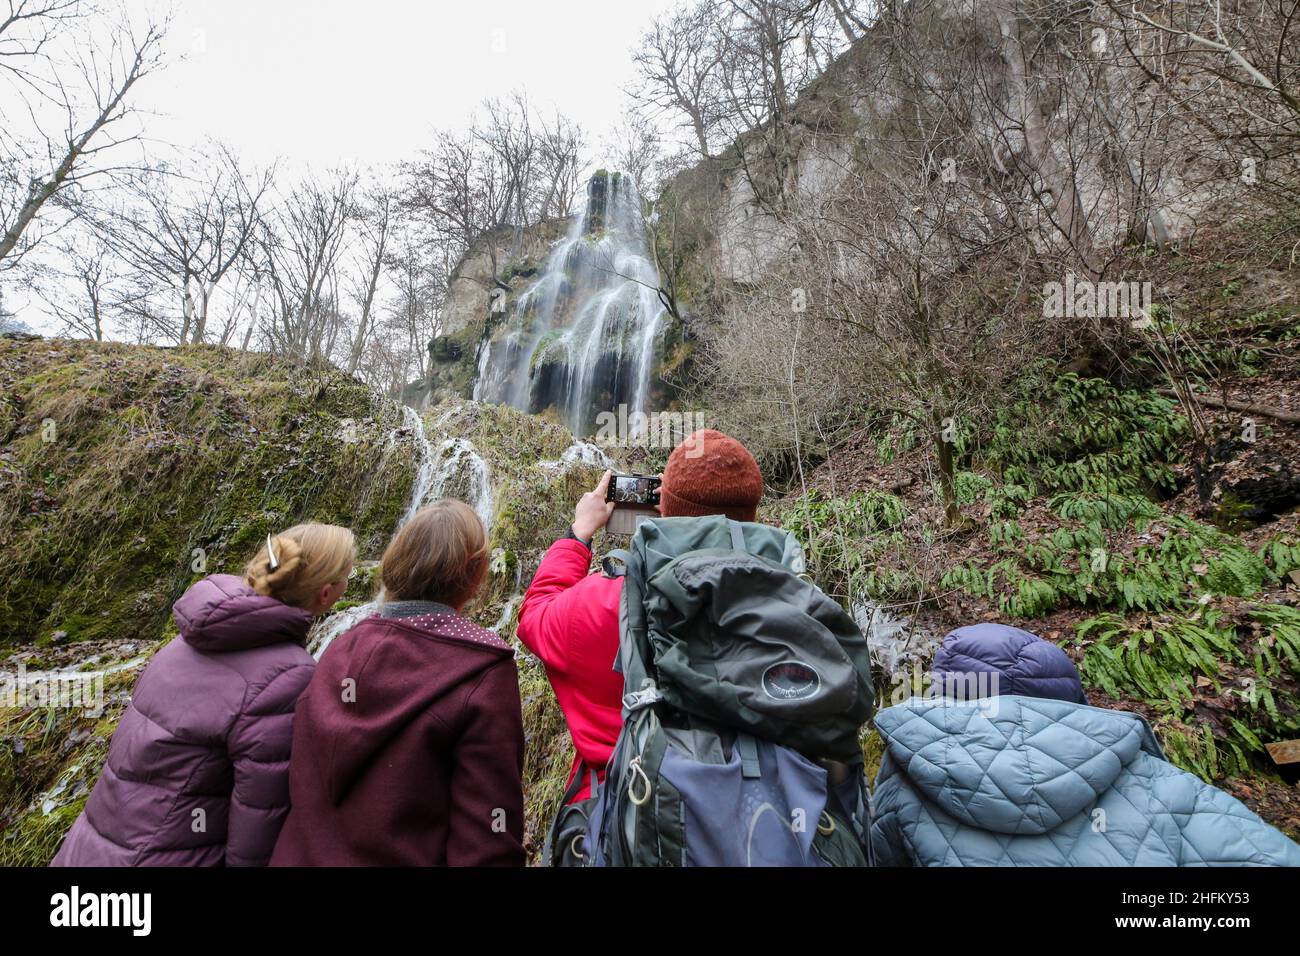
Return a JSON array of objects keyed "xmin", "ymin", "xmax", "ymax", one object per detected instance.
[{"xmin": 307, "ymin": 405, "xmax": 495, "ymax": 659}]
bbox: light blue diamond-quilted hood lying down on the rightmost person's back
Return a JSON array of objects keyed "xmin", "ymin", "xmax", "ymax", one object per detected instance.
[{"xmin": 876, "ymin": 697, "xmax": 1164, "ymax": 834}]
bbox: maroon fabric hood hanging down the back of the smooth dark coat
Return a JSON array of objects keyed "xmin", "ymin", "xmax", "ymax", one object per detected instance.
[{"xmin": 301, "ymin": 614, "xmax": 514, "ymax": 805}]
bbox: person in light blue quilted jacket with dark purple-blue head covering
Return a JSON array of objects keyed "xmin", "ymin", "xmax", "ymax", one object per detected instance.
[{"xmin": 871, "ymin": 624, "xmax": 1300, "ymax": 866}]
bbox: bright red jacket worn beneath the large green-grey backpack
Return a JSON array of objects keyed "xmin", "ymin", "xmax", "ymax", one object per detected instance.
[{"xmin": 519, "ymin": 538, "xmax": 623, "ymax": 800}]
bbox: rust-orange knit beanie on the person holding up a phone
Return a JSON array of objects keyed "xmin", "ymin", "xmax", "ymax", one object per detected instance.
[{"xmin": 659, "ymin": 428, "xmax": 763, "ymax": 522}]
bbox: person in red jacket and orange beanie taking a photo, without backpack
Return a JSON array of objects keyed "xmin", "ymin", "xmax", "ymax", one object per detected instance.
[{"xmin": 519, "ymin": 428, "xmax": 763, "ymax": 800}]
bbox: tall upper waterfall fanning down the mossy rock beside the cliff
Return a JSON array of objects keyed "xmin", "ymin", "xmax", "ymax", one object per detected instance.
[{"xmin": 475, "ymin": 170, "xmax": 667, "ymax": 436}]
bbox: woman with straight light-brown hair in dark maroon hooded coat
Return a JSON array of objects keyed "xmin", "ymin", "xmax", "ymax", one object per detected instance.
[{"xmin": 272, "ymin": 499, "xmax": 524, "ymax": 866}]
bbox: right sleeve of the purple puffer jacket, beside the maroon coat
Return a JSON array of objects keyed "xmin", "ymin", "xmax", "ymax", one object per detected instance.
[{"xmin": 226, "ymin": 662, "xmax": 315, "ymax": 866}]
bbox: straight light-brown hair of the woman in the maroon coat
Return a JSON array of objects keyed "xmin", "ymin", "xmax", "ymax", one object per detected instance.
[{"xmin": 381, "ymin": 498, "xmax": 488, "ymax": 607}]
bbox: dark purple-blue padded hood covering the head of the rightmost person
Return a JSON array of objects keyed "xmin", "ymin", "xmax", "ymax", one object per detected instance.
[{"xmin": 933, "ymin": 624, "xmax": 1088, "ymax": 704}]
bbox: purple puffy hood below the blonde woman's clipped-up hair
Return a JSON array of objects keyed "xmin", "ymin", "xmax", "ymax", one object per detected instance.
[{"xmin": 172, "ymin": 575, "xmax": 312, "ymax": 654}]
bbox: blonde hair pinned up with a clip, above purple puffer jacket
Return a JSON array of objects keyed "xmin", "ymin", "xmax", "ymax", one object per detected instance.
[{"xmin": 244, "ymin": 524, "xmax": 356, "ymax": 607}]
